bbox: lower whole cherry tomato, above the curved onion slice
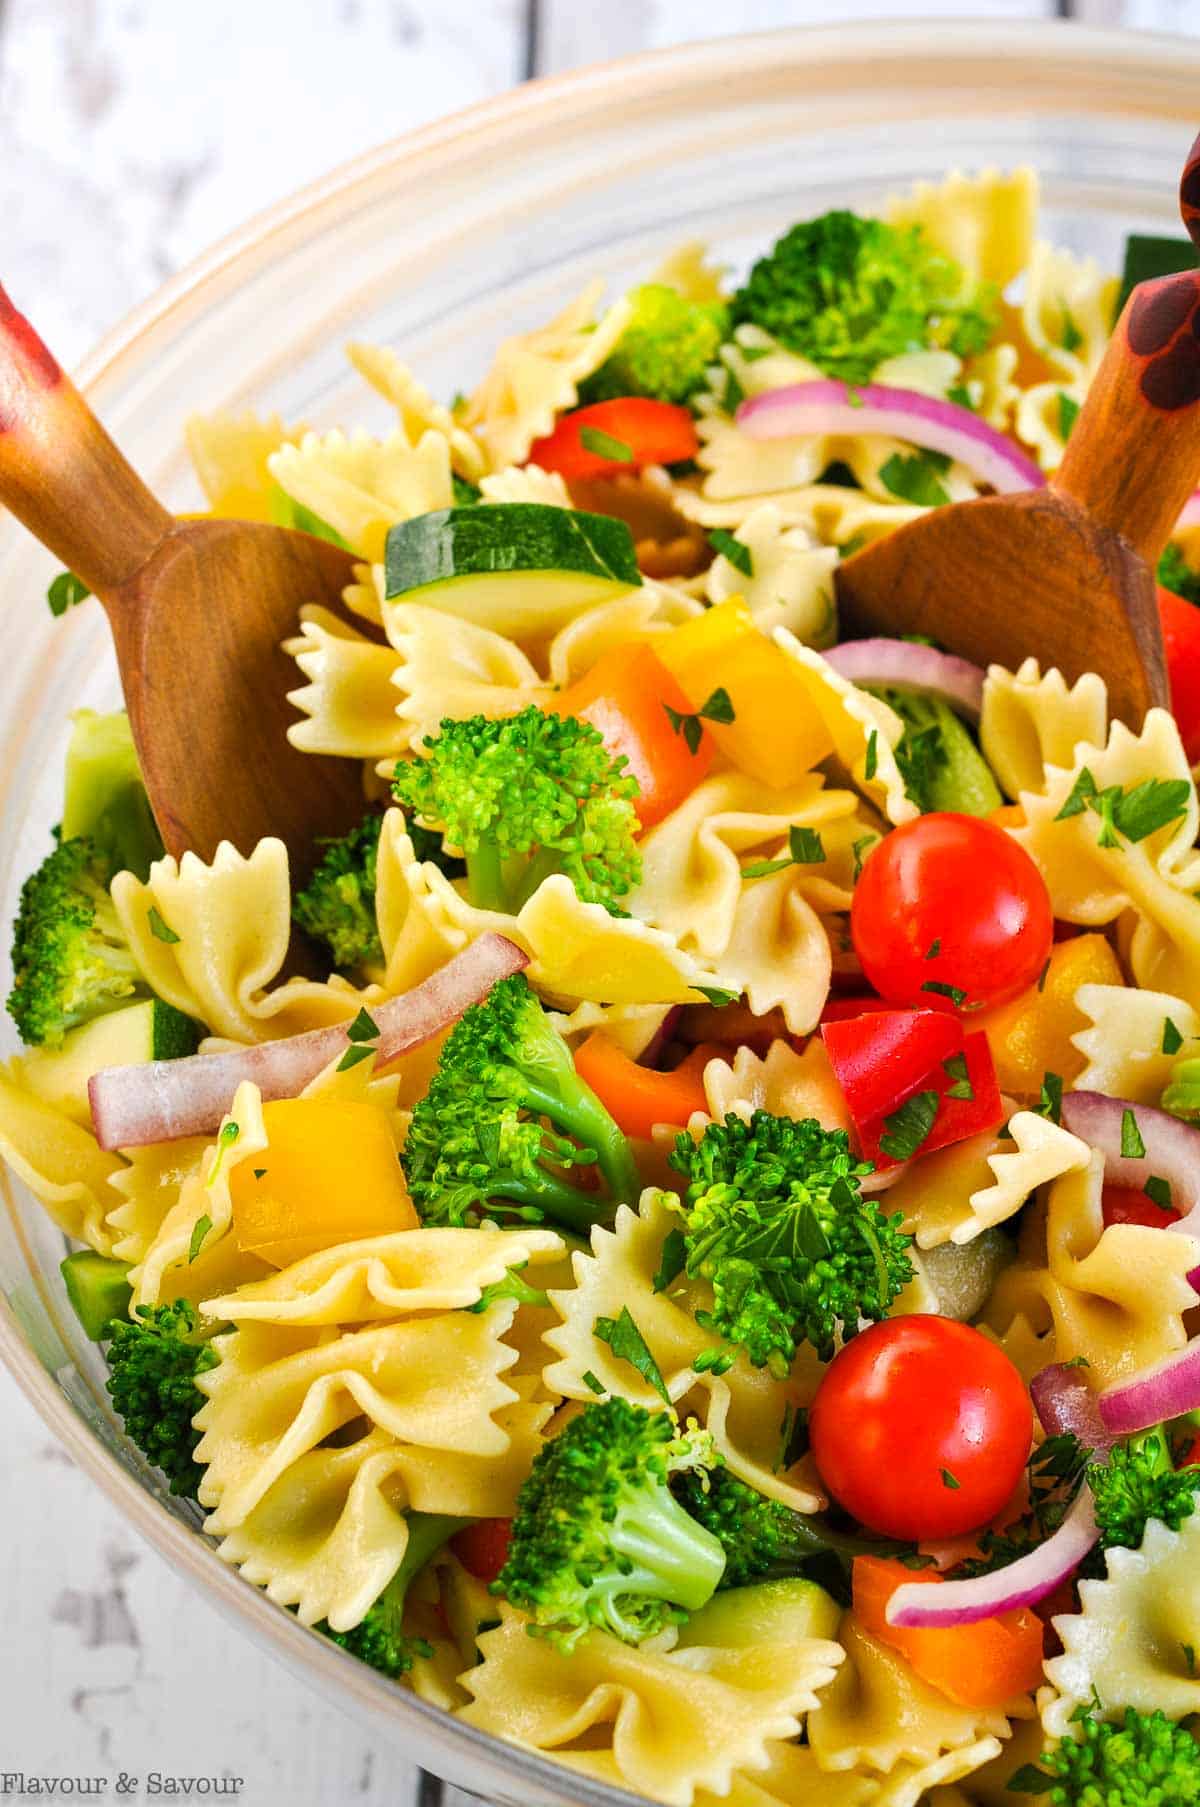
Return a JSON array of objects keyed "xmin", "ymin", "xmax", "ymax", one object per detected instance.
[{"xmin": 808, "ymin": 1315, "xmax": 1034, "ymax": 1538}]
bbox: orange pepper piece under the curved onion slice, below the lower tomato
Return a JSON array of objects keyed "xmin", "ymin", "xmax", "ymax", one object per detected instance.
[{"xmin": 853, "ymin": 1556, "xmax": 1043, "ymax": 1708}]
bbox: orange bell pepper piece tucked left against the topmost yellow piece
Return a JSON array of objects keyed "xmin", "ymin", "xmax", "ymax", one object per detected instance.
[{"xmin": 548, "ymin": 645, "xmax": 712, "ymax": 828}]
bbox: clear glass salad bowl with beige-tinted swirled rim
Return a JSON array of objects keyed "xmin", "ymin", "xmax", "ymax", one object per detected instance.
[{"xmin": 0, "ymin": 23, "xmax": 1200, "ymax": 1807}]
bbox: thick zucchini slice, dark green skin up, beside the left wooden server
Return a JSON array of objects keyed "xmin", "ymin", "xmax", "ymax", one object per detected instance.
[{"xmin": 385, "ymin": 502, "xmax": 642, "ymax": 640}]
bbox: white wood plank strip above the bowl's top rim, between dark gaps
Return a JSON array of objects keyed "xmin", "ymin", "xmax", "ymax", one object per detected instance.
[{"xmin": 537, "ymin": 0, "xmax": 1055, "ymax": 74}]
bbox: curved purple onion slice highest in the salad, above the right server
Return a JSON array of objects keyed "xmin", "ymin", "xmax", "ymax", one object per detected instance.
[{"xmin": 737, "ymin": 379, "xmax": 1046, "ymax": 495}]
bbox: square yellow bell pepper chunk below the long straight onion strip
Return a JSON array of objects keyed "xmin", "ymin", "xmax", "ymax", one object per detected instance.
[{"xmin": 230, "ymin": 1099, "xmax": 419, "ymax": 1267}]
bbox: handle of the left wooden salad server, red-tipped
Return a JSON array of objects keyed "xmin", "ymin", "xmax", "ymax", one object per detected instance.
[{"xmin": 0, "ymin": 287, "xmax": 175, "ymax": 598}]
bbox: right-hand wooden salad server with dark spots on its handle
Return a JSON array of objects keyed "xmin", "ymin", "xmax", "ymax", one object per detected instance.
[{"xmin": 837, "ymin": 137, "xmax": 1200, "ymax": 728}]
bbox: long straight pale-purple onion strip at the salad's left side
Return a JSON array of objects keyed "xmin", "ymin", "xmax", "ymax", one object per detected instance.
[{"xmin": 87, "ymin": 934, "xmax": 530, "ymax": 1149}]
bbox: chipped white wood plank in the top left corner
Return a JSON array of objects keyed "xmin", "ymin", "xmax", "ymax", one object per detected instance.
[{"xmin": 0, "ymin": 0, "xmax": 526, "ymax": 361}]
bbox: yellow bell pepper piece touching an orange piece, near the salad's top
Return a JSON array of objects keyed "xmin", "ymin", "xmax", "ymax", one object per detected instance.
[{"xmin": 654, "ymin": 596, "xmax": 833, "ymax": 790}]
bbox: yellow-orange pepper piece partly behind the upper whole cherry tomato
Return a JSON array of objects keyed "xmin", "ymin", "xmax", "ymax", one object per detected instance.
[{"xmin": 970, "ymin": 934, "xmax": 1124, "ymax": 1099}]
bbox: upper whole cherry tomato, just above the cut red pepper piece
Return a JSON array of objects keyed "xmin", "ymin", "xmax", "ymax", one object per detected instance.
[{"xmin": 849, "ymin": 811, "xmax": 1054, "ymax": 1010}]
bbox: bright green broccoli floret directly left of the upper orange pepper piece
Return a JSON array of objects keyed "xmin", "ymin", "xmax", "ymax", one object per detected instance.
[{"xmin": 392, "ymin": 707, "xmax": 642, "ymax": 911}]
